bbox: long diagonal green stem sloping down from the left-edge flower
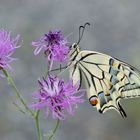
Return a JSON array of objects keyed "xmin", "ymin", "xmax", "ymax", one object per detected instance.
[{"xmin": 2, "ymin": 69, "xmax": 34, "ymax": 116}]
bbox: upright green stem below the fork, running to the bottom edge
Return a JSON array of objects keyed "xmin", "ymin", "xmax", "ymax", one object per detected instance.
[{"xmin": 34, "ymin": 110, "xmax": 42, "ymax": 140}]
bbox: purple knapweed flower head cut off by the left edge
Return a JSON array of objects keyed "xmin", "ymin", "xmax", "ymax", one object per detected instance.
[{"xmin": 0, "ymin": 29, "xmax": 20, "ymax": 69}]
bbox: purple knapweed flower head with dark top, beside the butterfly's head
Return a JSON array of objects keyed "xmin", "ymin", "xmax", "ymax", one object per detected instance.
[{"xmin": 32, "ymin": 31, "xmax": 69, "ymax": 62}]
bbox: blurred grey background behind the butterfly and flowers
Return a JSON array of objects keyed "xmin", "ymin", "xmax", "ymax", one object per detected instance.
[{"xmin": 0, "ymin": 0, "xmax": 140, "ymax": 140}]
